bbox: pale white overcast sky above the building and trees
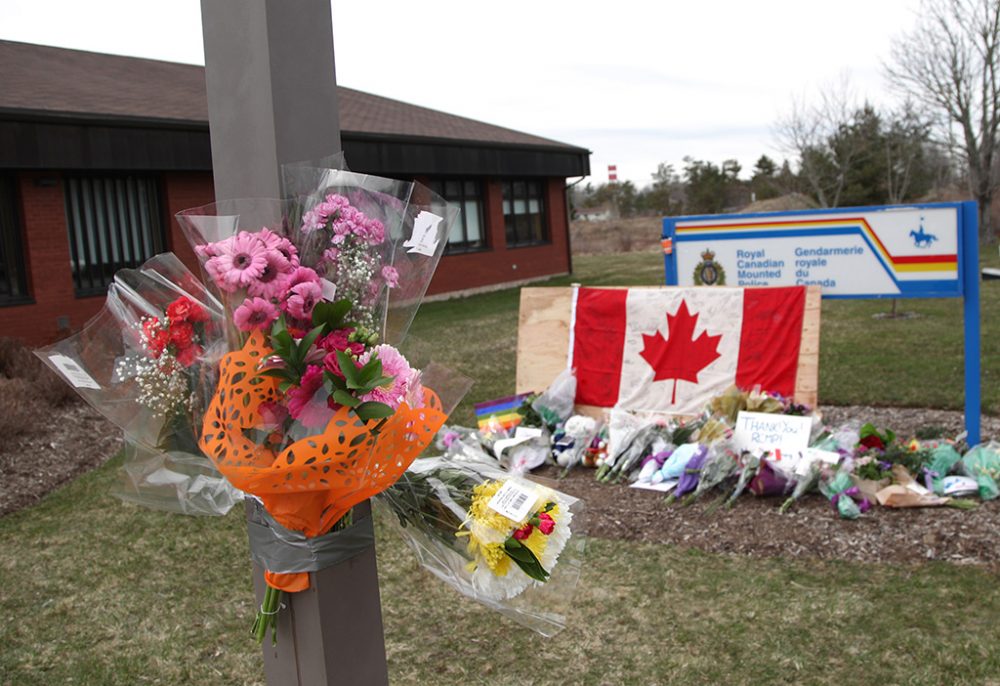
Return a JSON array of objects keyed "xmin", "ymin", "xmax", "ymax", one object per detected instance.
[{"xmin": 0, "ymin": 0, "xmax": 919, "ymax": 186}]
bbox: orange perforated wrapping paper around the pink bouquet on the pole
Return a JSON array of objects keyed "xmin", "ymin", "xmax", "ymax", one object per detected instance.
[{"xmin": 200, "ymin": 331, "xmax": 447, "ymax": 592}]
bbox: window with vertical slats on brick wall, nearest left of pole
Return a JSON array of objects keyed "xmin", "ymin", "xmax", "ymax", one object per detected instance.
[{"xmin": 66, "ymin": 176, "xmax": 166, "ymax": 296}]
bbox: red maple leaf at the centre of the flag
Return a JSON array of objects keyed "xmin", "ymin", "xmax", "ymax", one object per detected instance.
[{"xmin": 639, "ymin": 300, "xmax": 722, "ymax": 404}]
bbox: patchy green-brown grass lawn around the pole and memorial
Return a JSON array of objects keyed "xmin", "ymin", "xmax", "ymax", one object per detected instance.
[{"xmin": 0, "ymin": 246, "xmax": 1000, "ymax": 686}]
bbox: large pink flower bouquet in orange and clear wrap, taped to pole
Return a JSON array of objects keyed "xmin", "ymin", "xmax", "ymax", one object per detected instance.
[{"xmin": 178, "ymin": 166, "xmax": 468, "ymax": 640}]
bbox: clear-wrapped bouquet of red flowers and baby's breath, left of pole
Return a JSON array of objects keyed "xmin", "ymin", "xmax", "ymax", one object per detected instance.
[{"xmin": 36, "ymin": 253, "xmax": 242, "ymax": 515}]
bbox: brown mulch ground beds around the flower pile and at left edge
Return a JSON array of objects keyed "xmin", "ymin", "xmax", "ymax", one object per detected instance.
[{"xmin": 0, "ymin": 403, "xmax": 1000, "ymax": 569}]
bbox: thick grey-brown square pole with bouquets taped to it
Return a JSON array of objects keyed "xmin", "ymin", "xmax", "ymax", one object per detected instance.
[{"xmin": 201, "ymin": 0, "xmax": 389, "ymax": 686}]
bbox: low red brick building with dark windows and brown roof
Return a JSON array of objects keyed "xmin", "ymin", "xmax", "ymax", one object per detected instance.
[{"xmin": 0, "ymin": 40, "xmax": 589, "ymax": 344}]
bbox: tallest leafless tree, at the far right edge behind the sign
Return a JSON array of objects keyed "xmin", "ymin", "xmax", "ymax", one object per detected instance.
[{"xmin": 886, "ymin": 0, "xmax": 1000, "ymax": 239}]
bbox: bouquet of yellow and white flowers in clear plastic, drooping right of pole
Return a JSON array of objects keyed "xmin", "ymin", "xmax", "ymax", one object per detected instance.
[{"xmin": 376, "ymin": 457, "xmax": 585, "ymax": 636}]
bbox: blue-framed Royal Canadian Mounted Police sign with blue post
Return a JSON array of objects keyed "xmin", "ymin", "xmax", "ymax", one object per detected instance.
[{"xmin": 662, "ymin": 201, "xmax": 981, "ymax": 445}]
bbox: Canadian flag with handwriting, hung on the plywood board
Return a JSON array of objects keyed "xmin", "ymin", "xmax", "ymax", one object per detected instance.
[{"xmin": 570, "ymin": 286, "xmax": 806, "ymax": 415}]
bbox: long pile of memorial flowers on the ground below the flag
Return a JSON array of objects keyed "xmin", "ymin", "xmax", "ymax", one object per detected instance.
[{"xmin": 443, "ymin": 371, "xmax": 1000, "ymax": 519}]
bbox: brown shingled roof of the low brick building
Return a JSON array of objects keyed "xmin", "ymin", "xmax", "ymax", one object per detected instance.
[{"xmin": 0, "ymin": 40, "xmax": 585, "ymax": 152}]
